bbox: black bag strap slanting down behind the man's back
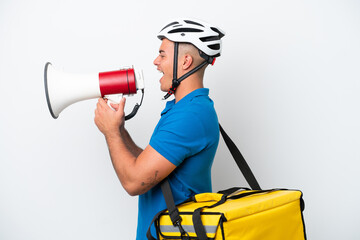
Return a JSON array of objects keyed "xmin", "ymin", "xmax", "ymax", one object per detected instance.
[{"xmin": 219, "ymin": 124, "xmax": 261, "ymax": 190}]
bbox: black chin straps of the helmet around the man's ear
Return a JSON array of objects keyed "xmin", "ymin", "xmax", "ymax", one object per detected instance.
[{"xmin": 163, "ymin": 42, "xmax": 211, "ymax": 100}]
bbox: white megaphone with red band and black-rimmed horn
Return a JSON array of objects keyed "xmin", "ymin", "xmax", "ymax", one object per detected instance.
[{"xmin": 44, "ymin": 62, "xmax": 144, "ymax": 120}]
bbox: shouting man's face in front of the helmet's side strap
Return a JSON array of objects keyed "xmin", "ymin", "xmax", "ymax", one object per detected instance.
[{"xmin": 154, "ymin": 38, "xmax": 174, "ymax": 92}]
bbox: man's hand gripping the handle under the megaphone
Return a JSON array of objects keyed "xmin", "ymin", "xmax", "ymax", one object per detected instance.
[{"xmin": 94, "ymin": 98, "xmax": 126, "ymax": 137}]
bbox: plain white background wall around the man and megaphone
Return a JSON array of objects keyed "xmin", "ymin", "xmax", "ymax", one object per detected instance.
[{"xmin": 0, "ymin": 0, "xmax": 360, "ymax": 240}]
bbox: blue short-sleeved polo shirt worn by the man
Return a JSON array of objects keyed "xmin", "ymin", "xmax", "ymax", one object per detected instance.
[{"xmin": 136, "ymin": 88, "xmax": 219, "ymax": 240}]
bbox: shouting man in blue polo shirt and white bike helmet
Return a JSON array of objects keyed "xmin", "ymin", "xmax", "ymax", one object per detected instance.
[{"xmin": 95, "ymin": 19, "xmax": 224, "ymax": 239}]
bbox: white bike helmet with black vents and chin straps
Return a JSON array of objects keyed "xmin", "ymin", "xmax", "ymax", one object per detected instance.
[{"xmin": 157, "ymin": 18, "xmax": 225, "ymax": 99}]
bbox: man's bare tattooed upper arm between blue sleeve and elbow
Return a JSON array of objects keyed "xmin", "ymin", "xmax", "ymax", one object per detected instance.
[{"xmin": 127, "ymin": 145, "xmax": 176, "ymax": 195}]
